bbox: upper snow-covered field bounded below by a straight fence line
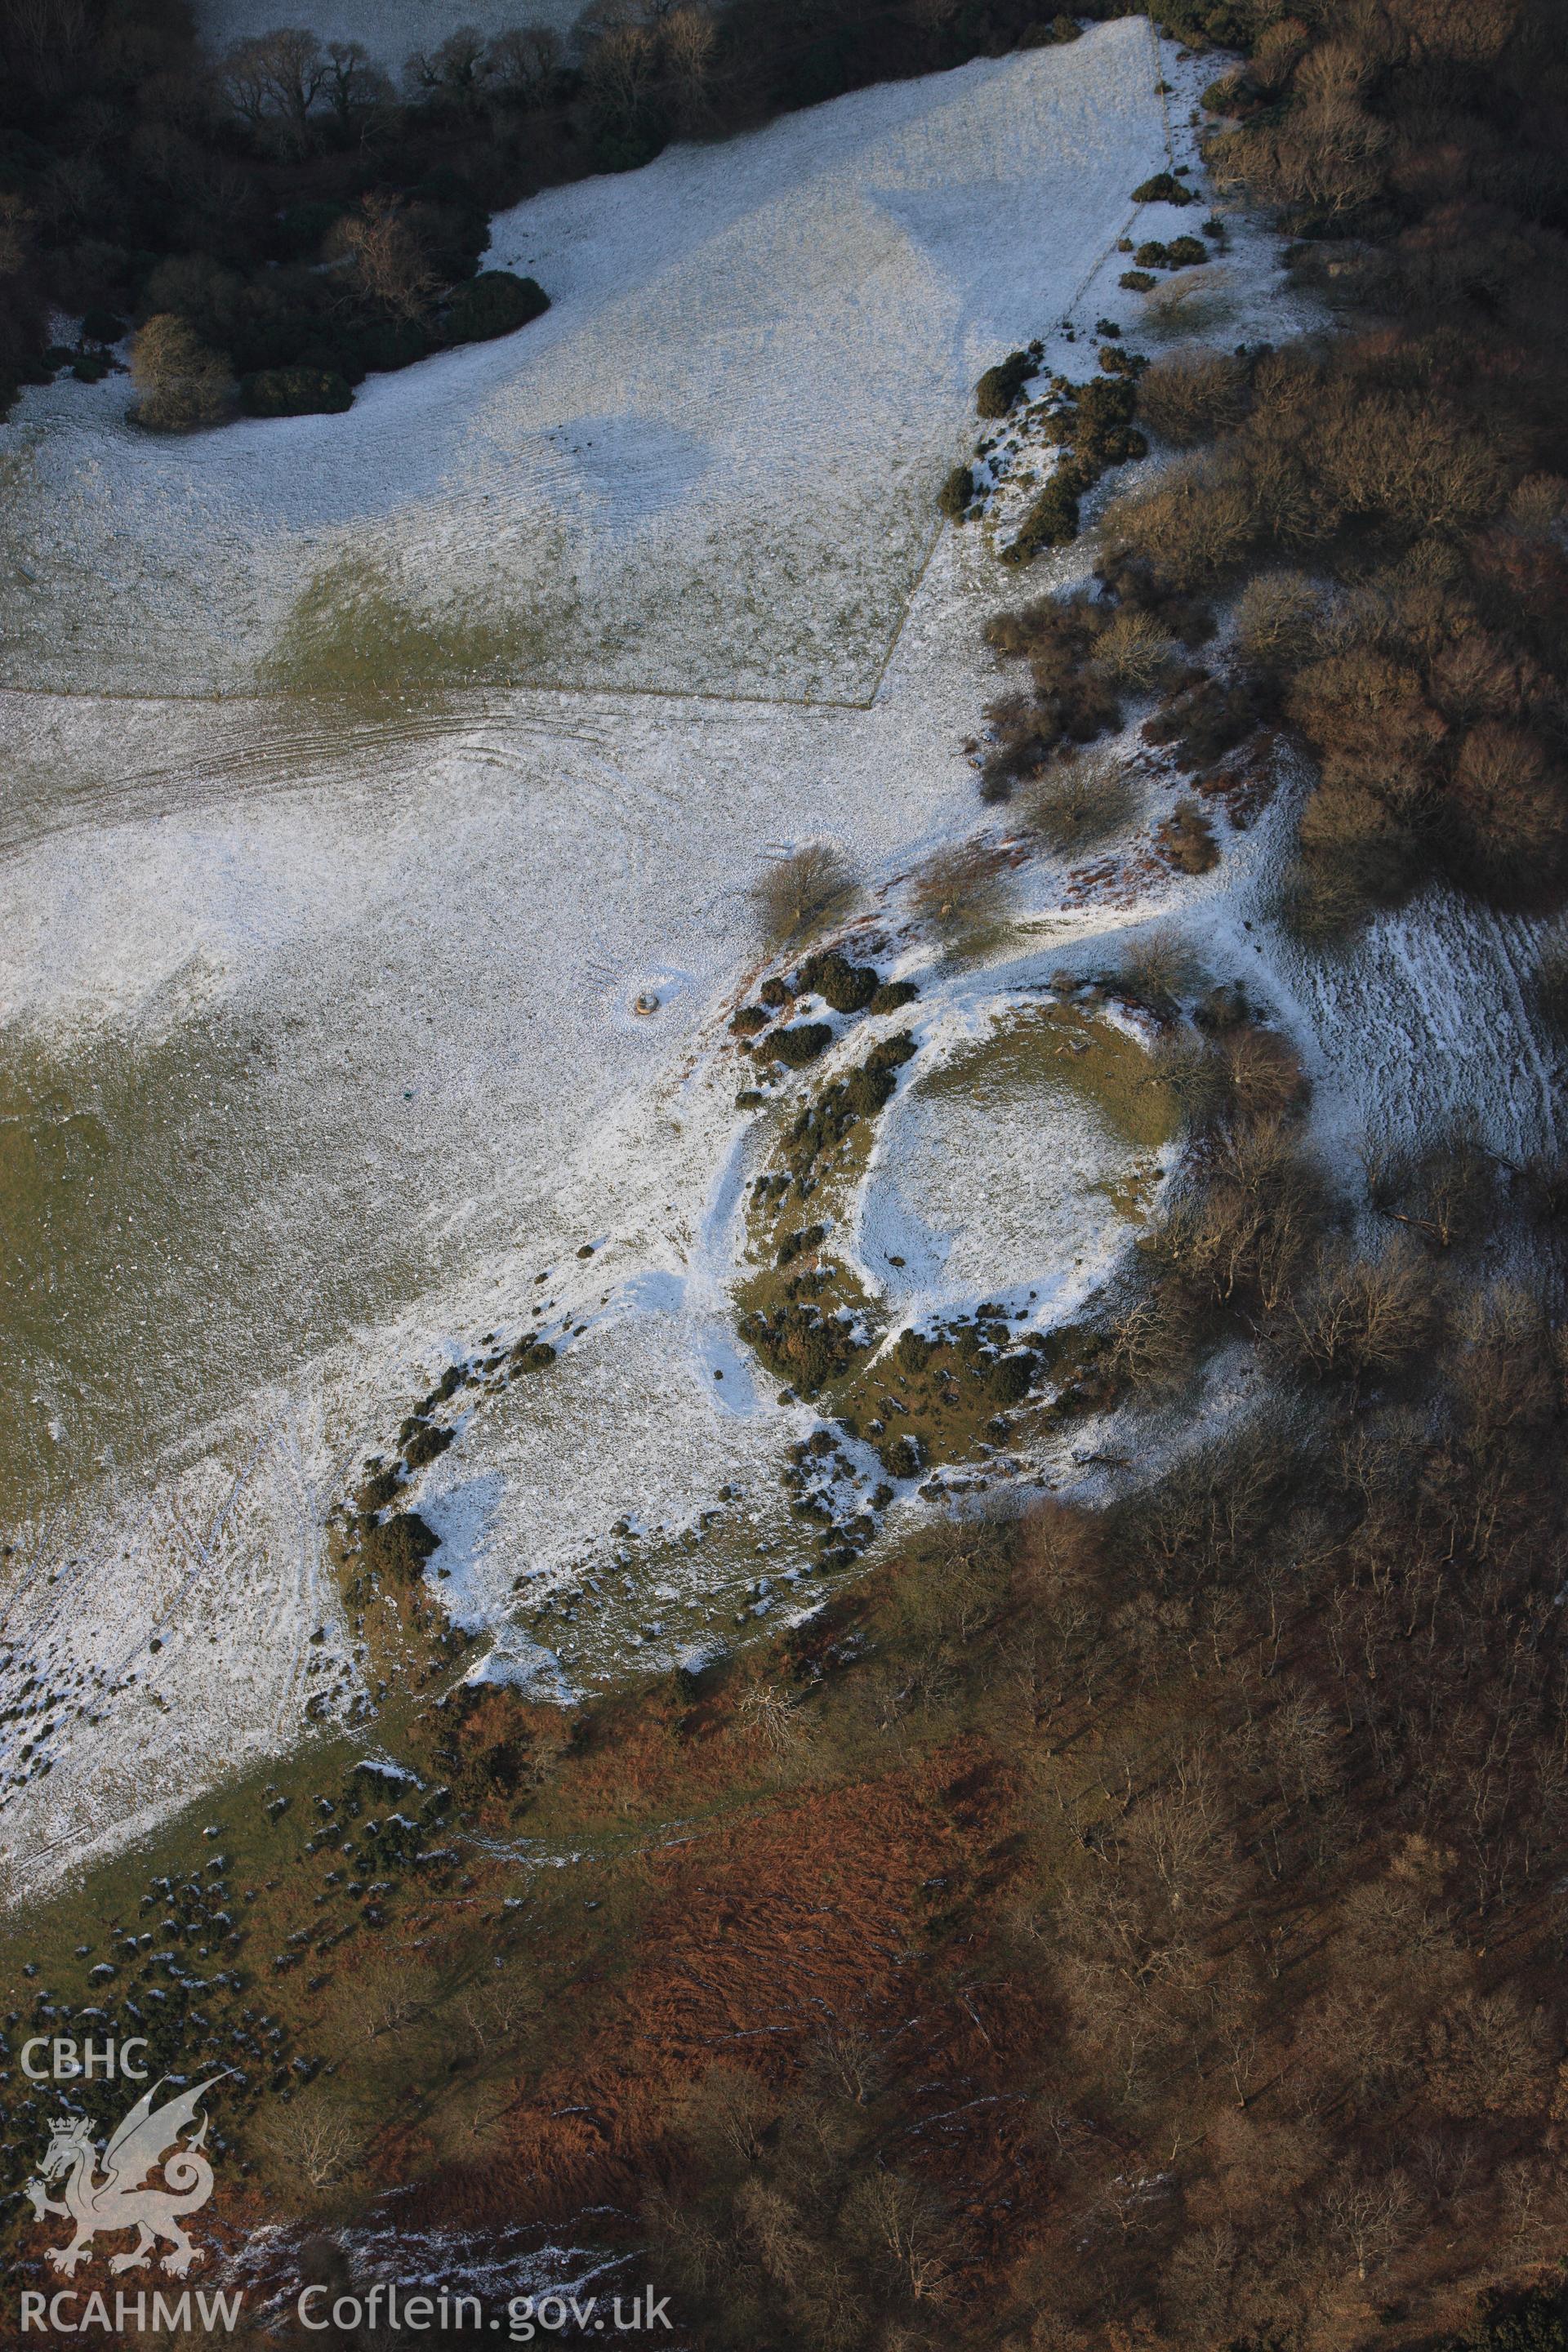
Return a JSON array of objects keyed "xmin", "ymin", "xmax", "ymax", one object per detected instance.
[{"xmin": 0, "ymin": 16, "xmax": 1164, "ymax": 701}]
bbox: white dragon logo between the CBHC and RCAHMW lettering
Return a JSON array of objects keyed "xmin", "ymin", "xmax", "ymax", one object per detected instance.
[{"xmin": 24, "ymin": 2068, "xmax": 228, "ymax": 2279}]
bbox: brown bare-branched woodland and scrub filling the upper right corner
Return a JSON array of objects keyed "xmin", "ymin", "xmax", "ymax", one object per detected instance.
[{"xmin": 968, "ymin": 0, "xmax": 1568, "ymax": 936}]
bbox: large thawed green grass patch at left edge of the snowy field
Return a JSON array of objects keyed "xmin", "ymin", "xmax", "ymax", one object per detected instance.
[{"xmin": 0, "ymin": 1009, "xmax": 428, "ymax": 1517}]
